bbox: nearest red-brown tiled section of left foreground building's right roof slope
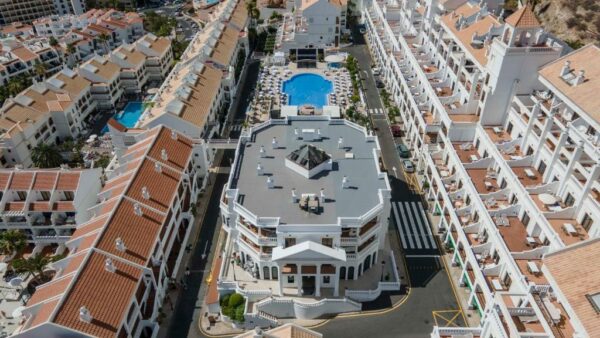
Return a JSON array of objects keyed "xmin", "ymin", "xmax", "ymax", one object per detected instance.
[{"xmin": 54, "ymin": 252, "xmax": 142, "ymax": 337}]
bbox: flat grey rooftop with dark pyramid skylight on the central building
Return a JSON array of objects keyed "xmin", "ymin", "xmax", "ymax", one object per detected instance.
[{"xmin": 229, "ymin": 120, "xmax": 389, "ymax": 224}]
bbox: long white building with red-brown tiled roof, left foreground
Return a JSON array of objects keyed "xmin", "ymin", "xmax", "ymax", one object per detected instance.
[{"xmin": 13, "ymin": 127, "xmax": 210, "ymax": 337}]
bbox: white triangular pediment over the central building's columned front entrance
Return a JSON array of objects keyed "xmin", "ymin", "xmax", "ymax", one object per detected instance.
[{"xmin": 272, "ymin": 241, "xmax": 346, "ymax": 262}]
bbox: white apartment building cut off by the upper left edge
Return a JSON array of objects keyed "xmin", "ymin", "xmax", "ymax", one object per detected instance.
[{"xmin": 0, "ymin": 37, "xmax": 62, "ymax": 85}]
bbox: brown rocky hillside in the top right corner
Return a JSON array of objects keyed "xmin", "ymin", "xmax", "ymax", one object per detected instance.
[{"xmin": 528, "ymin": 0, "xmax": 600, "ymax": 48}]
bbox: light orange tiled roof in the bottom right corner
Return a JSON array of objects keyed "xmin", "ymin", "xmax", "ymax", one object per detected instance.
[{"xmin": 543, "ymin": 239, "xmax": 600, "ymax": 337}]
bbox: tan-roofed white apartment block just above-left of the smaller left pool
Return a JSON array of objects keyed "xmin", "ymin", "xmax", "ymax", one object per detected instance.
[{"xmin": 79, "ymin": 56, "xmax": 124, "ymax": 109}]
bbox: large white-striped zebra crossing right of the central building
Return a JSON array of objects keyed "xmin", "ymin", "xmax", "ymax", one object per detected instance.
[{"xmin": 392, "ymin": 202, "xmax": 437, "ymax": 250}]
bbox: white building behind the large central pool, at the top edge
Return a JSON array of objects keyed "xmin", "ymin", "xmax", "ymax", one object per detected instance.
[{"xmin": 276, "ymin": 0, "xmax": 348, "ymax": 52}]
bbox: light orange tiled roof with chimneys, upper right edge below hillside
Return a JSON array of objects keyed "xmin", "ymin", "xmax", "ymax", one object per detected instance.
[{"xmin": 540, "ymin": 44, "xmax": 600, "ymax": 122}]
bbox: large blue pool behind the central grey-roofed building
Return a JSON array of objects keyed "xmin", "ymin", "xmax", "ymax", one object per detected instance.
[{"xmin": 283, "ymin": 73, "xmax": 333, "ymax": 108}]
